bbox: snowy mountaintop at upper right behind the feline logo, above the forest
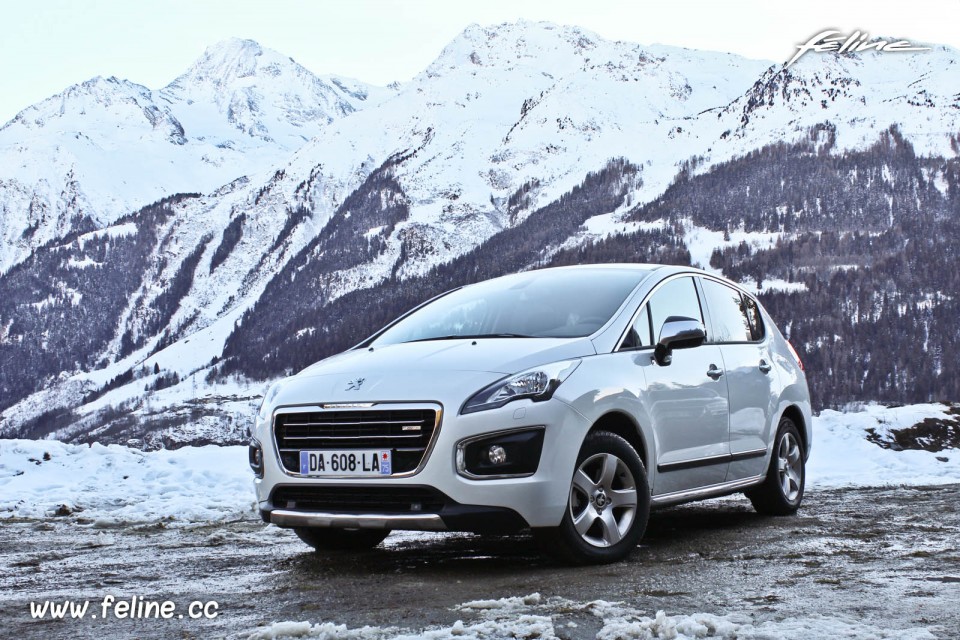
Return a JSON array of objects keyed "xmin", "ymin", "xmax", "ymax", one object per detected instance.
[{"xmin": 721, "ymin": 40, "xmax": 960, "ymax": 157}]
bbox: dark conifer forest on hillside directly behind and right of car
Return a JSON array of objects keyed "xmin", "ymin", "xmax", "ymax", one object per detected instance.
[{"xmin": 218, "ymin": 125, "xmax": 960, "ymax": 407}]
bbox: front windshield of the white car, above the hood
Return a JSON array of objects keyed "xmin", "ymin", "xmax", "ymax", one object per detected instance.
[{"xmin": 372, "ymin": 269, "xmax": 649, "ymax": 345}]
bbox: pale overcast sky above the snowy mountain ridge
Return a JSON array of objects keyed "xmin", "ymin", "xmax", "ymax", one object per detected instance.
[{"xmin": 0, "ymin": 0, "xmax": 960, "ymax": 123}]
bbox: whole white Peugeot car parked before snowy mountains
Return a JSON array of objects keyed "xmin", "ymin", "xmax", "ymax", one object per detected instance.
[{"xmin": 250, "ymin": 264, "xmax": 811, "ymax": 562}]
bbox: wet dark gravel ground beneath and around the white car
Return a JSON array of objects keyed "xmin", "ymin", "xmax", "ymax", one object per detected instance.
[{"xmin": 0, "ymin": 485, "xmax": 960, "ymax": 638}]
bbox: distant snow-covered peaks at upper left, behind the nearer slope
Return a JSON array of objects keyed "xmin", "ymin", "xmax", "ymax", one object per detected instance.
[{"xmin": 0, "ymin": 39, "xmax": 391, "ymax": 273}]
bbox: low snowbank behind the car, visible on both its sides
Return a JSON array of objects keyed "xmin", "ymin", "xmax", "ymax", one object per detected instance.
[{"xmin": 0, "ymin": 404, "xmax": 960, "ymax": 527}]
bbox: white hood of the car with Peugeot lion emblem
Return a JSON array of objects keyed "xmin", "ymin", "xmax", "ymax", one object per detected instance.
[{"xmin": 271, "ymin": 338, "xmax": 595, "ymax": 406}]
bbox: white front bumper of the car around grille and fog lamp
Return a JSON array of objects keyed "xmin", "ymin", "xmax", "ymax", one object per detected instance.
[{"xmin": 254, "ymin": 398, "xmax": 589, "ymax": 532}]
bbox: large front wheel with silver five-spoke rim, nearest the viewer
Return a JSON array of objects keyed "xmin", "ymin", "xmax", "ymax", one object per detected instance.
[{"xmin": 534, "ymin": 431, "xmax": 650, "ymax": 564}]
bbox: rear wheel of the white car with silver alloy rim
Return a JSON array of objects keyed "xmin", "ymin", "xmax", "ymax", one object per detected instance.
[{"xmin": 745, "ymin": 418, "xmax": 807, "ymax": 516}]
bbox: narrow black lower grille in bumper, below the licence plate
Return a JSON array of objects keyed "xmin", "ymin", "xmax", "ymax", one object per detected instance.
[{"xmin": 271, "ymin": 487, "xmax": 449, "ymax": 514}]
